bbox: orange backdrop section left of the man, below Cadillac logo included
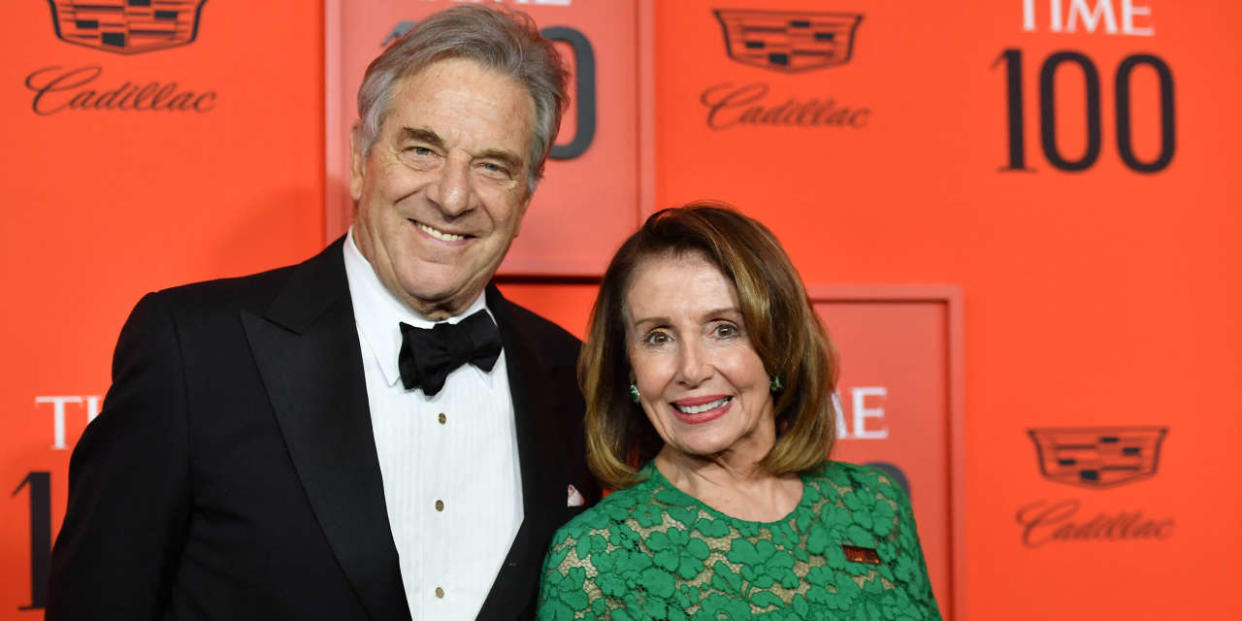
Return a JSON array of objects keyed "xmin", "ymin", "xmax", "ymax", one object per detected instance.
[{"xmin": 0, "ymin": 0, "xmax": 323, "ymax": 620}]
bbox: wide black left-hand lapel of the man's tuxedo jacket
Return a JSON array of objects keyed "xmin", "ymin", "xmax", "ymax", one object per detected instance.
[{"xmin": 234, "ymin": 240, "xmax": 410, "ymax": 620}]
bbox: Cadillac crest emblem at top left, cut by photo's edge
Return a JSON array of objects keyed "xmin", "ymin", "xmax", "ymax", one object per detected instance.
[{"xmin": 47, "ymin": 0, "xmax": 206, "ymax": 53}]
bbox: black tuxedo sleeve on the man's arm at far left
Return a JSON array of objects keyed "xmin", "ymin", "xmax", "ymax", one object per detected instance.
[{"xmin": 47, "ymin": 294, "xmax": 190, "ymax": 621}]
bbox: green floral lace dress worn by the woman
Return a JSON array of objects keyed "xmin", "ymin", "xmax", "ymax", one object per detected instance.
[{"xmin": 539, "ymin": 462, "xmax": 940, "ymax": 621}]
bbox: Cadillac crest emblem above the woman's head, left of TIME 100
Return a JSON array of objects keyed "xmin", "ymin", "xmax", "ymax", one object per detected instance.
[{"xmin": 715, "ymin": 9, "xmax": 862, "ymax": 73}]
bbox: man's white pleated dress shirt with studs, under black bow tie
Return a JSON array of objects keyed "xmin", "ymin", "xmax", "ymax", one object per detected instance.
[{"xmin": 344, "ymin": 230, "xmax": 523, "ymax": 620}]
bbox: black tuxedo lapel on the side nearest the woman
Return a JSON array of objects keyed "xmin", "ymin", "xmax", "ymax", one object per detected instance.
[{"xmin": 478, "ymin": 286, "xmax": 565, "ymax": 619}]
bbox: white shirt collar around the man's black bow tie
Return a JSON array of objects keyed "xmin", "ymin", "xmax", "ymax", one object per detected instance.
[{"xmin": 344, "ymin": 232, "xmax": 496, "ymax": 386}]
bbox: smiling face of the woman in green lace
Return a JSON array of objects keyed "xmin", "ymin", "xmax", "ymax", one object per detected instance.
[{"xmin": 625, "ymin": 253, "xmax": 775, "ymax": 461}]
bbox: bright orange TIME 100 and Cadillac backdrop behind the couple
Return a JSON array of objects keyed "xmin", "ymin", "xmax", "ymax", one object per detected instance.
[{"xmin": 0, "ymin": 0, "xmax": 1242, "ymax": 621}]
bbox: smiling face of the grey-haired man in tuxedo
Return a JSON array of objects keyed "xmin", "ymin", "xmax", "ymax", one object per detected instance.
[{"xmin": 349, "ymin": 58, "xmax": 534, "ymax": 319}]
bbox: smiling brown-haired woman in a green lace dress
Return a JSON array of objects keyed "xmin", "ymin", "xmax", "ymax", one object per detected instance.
[{"xmin": 539, "ymin": 205, "xmax": 939, "ymax": 620}]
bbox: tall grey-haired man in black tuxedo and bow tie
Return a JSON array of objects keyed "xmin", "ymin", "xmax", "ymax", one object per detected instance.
[{"xmin": 47, "ymin": 6, "xmax": 599, "ymax": 621}]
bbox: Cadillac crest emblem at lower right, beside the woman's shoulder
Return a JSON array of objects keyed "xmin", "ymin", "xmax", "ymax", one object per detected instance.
[{"xmin": 1028, "ymin": 427, "xmax": 1169, "ymax": 488}]
